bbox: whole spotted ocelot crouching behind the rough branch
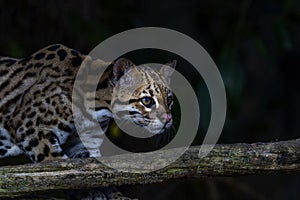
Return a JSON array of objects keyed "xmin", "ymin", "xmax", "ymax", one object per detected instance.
[{"xmin": 0, "ymin": 44, "xmax": 176, "ymax": 162}]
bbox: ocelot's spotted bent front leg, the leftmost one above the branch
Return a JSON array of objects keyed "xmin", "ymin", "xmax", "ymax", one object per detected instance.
[{"xmin": 6, "ymin": 111, "xmax": 73, "ymax": 162}]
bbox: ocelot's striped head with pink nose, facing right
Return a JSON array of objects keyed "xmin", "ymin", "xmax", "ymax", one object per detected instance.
[{"xmin": 111, "ymin": 58, "xmax": 176, "ymax": 134}]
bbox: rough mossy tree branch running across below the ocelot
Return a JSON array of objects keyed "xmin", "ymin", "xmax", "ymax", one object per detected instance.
[{"xmin": 0, "ymin": 139, "xmax": 300, "ymax": 197}]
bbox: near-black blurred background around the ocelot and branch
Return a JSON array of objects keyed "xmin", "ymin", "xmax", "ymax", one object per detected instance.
[{"xmin": 0, "ymin": 0, "xmax": 300, "ymax": 200}]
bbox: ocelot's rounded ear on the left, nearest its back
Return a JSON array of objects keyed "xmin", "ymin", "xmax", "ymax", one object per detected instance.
[{"xmin": 113, "ymin": 58, "xmax": 135, "ymax": 83}]
